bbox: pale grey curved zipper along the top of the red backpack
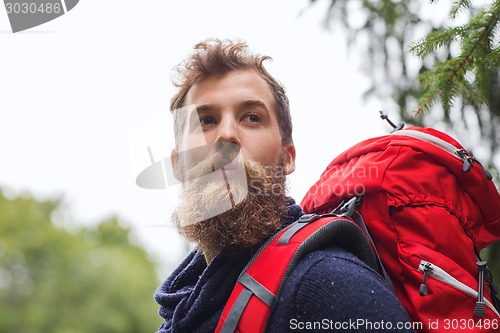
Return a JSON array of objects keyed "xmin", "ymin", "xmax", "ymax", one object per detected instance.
[{"xmin": 391, "ymin": 130, "xmax": 493, "ymax": 180}]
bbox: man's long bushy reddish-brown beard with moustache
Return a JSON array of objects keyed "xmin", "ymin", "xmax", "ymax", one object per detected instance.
[{"xmin": 172, "ymin": 154, "xmax": 287, "ymax": 261}]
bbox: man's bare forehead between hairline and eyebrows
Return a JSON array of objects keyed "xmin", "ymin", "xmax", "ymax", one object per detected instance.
[{"xmin": 184, "ymin": 69, "xmax": 275, "ymax": 110}]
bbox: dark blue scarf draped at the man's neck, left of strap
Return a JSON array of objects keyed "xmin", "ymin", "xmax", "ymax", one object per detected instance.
[{"xmin": 154, "ymin": 198, "xmax": 303, "ymax": 333}]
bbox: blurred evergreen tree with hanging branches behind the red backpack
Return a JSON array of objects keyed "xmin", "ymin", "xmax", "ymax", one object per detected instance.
[{"xmin": 310, "ymin": 0, "xmax": 500, "ymax": 288}]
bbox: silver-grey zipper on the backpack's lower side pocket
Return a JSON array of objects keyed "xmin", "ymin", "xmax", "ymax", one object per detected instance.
[{"xmin": 418, "ymin": 260, "xmax": 500, "ymax": 318}]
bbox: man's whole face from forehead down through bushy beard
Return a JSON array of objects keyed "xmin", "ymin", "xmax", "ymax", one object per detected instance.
[{"xmin": 172, "ymin": 70, "xmax": 295, "ymax": 261}]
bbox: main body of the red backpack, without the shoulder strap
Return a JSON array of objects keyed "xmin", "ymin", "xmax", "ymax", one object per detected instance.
[{"xmin": 302, "ymin": 122, "xmax": 500, "ymax": 332}]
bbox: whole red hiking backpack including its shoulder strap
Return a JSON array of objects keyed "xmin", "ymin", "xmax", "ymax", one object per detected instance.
[{"xmin": 216, "ymin": 120, "xmax": 500, "ymax": 333}]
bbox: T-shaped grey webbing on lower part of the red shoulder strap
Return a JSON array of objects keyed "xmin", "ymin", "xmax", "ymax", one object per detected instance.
[{"xmin": 220, "ymin": 273, "xmax": 275, "ymax": 333}]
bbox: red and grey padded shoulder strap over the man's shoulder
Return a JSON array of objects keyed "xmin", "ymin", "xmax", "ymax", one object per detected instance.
[{"xmin": 215, "ymin": 214, "xmax": 378, "ymax": 333}]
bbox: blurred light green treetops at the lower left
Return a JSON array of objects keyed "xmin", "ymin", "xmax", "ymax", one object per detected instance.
[{"xmin": 0, "ymin": 192, "xmax": 160, "ymax": 333}]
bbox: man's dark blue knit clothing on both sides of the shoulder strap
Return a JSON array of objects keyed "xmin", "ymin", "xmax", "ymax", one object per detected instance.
[{"xmin": 155, "ymin": 202, "xmax": 413, "ymax": 333}]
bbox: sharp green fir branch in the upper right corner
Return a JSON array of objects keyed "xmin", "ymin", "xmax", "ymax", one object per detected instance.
[{"xmin": 410, "ymin": 1, "xmax": 500, "ymax": 113}]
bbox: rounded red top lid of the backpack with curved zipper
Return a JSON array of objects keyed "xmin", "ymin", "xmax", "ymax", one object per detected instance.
[{"xmin": 301, "ymin": 126, "xmax": 500, "ymax": 250}]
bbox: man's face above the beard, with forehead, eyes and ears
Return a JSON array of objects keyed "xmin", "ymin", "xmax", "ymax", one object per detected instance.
[{"xmin": 172, "ymin": 70, "xmax": 295, "ymax": 174}]
